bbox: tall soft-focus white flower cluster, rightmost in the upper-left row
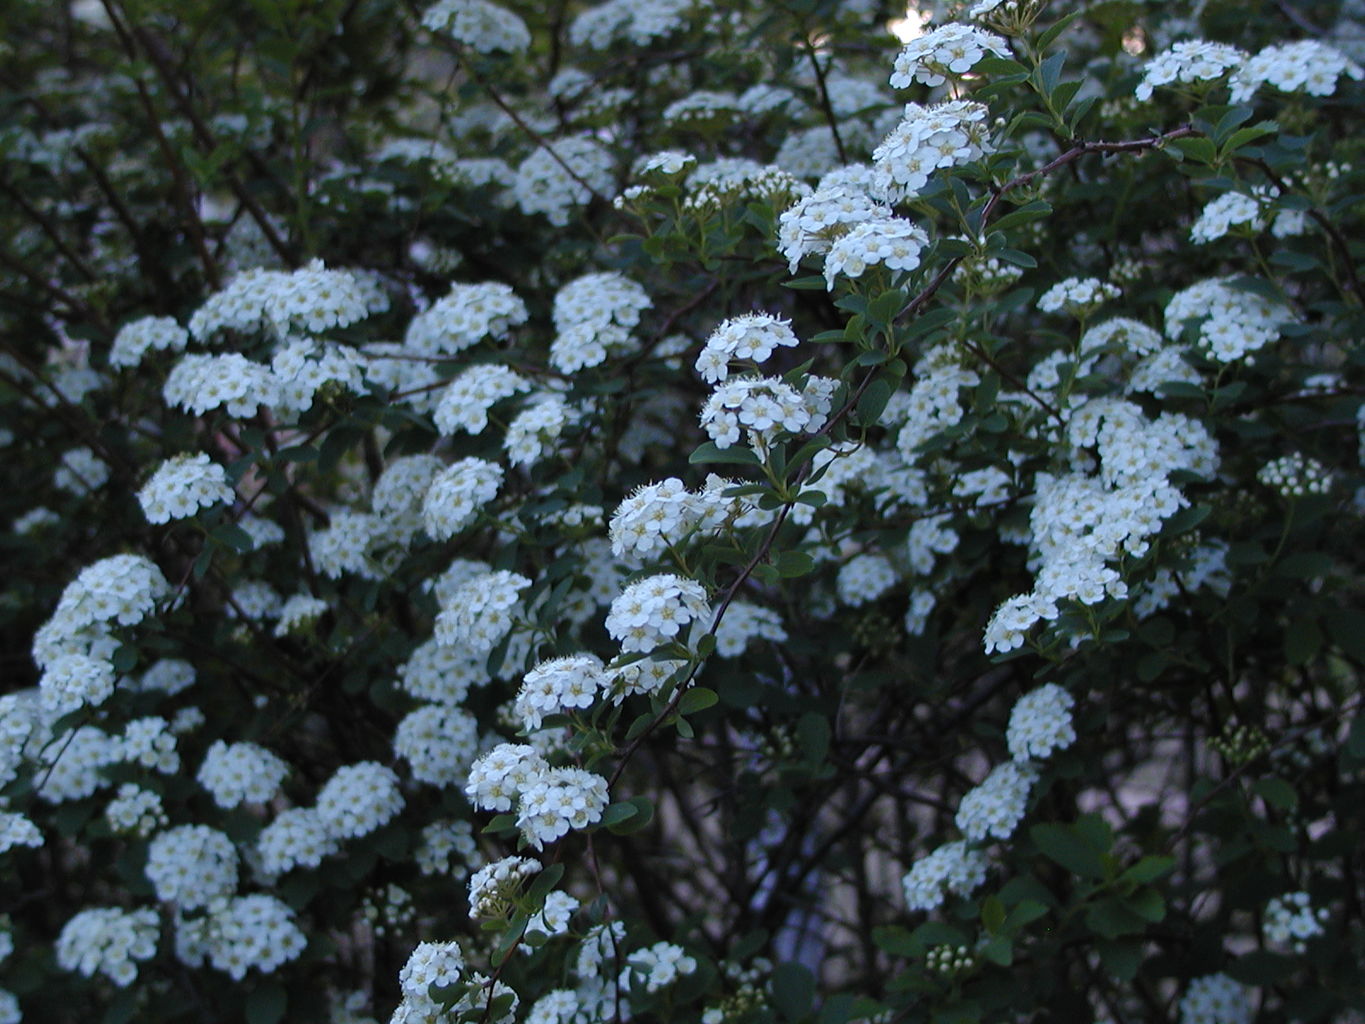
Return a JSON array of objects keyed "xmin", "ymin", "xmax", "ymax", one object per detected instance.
[{"xmin": 550, "ymin": 272, "xmax": 652, "ymax": 373}]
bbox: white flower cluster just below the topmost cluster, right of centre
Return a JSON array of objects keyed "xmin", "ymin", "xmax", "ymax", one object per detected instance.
[{"xmin": 872, "ymin": 100, "xmax": 990, "ymax": 202}]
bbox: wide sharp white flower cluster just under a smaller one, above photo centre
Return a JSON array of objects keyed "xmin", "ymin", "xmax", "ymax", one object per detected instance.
[{"xmin": 700, "ymin": 377, "xmax": 837, "ymax": 455}]
